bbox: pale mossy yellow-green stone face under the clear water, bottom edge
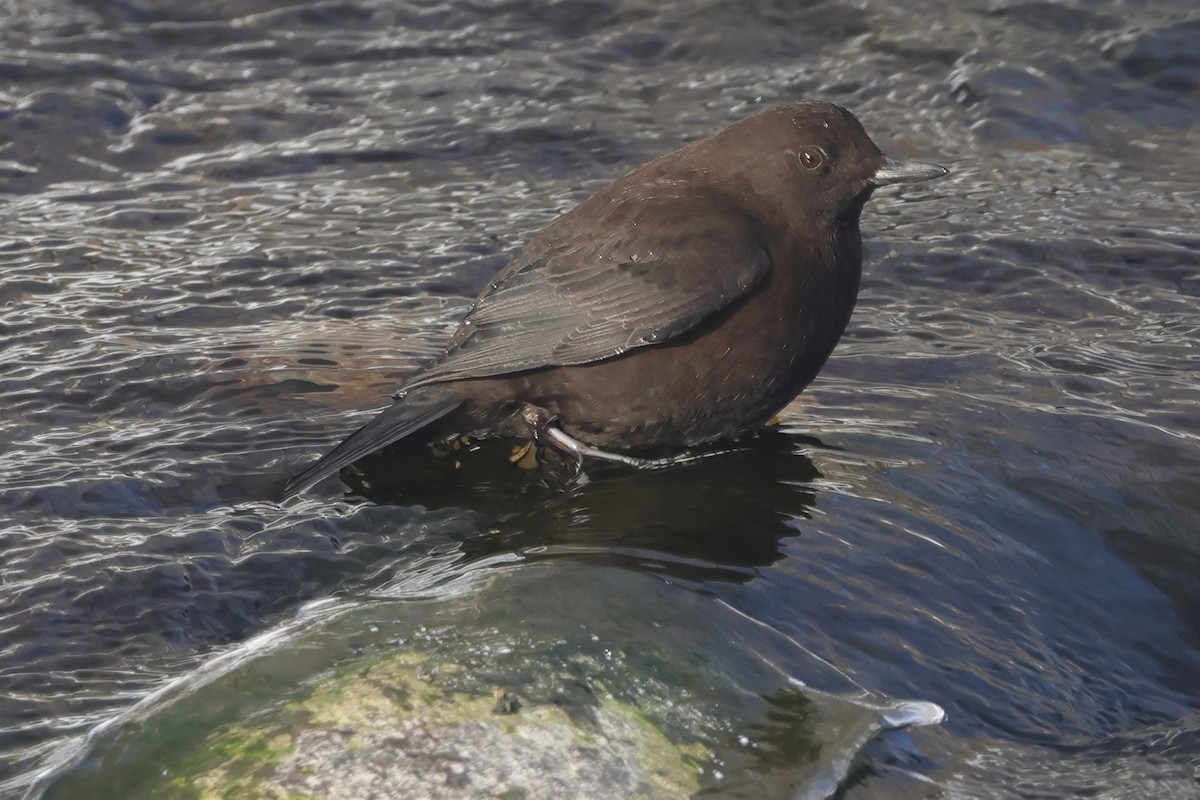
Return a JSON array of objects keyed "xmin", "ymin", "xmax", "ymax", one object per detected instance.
[{"xmin": 170, "ymin": 656, "xmax": 704, "ymax": 800}]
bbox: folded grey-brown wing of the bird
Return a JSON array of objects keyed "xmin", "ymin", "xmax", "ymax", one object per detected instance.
[{"xmin": 406, "ymin": 200, "xmax": 770, "ymax": 391}]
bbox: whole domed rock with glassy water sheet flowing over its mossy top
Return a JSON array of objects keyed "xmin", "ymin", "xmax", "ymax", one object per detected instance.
[{"xmin": 26, "ymin": 563, "xmax": 942, "ymax": 800}]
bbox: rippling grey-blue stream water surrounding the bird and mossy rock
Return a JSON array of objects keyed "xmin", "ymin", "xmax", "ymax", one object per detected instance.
[{"xmin": 0, "ymin": 0, "xmax": 1200, "ymax": 798}]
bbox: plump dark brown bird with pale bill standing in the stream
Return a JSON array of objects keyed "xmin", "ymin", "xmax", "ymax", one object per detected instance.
[{"xmin": 284, "ymin": 101, "xmax": 949, "ymax": 498}]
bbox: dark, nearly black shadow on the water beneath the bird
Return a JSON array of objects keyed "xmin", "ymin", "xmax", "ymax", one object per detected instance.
[{"xmin": 344, "ymin": 431, "xmax": 820, "ymax": 582}]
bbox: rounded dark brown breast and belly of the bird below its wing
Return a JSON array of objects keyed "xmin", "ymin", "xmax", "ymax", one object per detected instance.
[{"xmin": 514, "ymin": 244, "xmax": 858, "ymax": 447}]
